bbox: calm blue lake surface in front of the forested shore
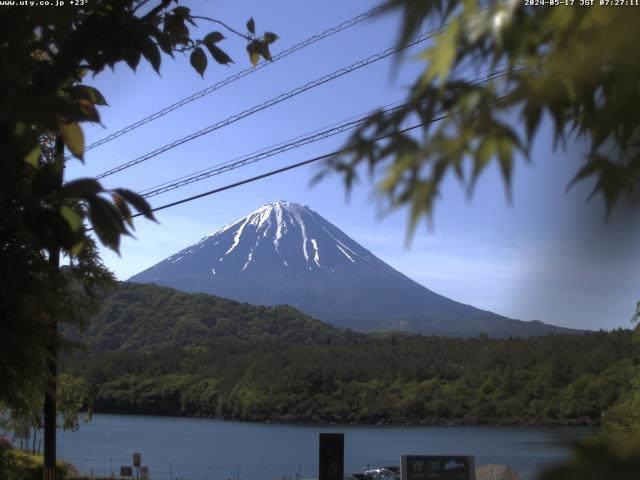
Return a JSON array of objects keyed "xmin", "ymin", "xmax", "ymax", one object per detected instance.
[{"xmin": 58, "ymin": 415, "xmax": 597, "ymax": 480}]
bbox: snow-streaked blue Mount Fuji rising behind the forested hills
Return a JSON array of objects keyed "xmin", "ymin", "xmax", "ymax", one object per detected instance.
[{"xmin": 129, "ymin": 201, "xmax": 572, "ymax": 337}]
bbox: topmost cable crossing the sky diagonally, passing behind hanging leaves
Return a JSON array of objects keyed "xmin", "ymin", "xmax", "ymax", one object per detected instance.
[{"xmin": 77, "ymin": 6, "xmax": 382, "ymax": 158}]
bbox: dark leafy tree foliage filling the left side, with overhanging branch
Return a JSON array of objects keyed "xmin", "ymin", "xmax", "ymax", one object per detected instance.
[{"xmin": 0, "ymin": 0, "xmax": 277, "ymax": 410}]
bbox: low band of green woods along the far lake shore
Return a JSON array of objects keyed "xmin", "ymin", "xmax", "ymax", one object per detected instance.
[{"xmin": 64, "ymin": 331, "xmax": 639, "ymax": 425}]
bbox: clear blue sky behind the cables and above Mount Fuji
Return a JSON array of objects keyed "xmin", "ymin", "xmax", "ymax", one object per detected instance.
[{"xmin": 67, "ymin": 0, "xmax": 640, "ymax": 329}]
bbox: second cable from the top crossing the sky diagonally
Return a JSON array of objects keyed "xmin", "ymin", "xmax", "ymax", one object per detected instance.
[{"xmin": 96, "ymin": 30, "xmax": 440, "ymax": 179}]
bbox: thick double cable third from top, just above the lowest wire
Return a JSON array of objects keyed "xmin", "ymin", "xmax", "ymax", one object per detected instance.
[{"xmin": 139, "ymin": 66, "xmax": 506, "ymax": 198}]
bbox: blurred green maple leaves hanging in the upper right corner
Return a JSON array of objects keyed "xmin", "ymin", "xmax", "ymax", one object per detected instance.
[{"xmin": 325, "ymin": 0, "xmax": 640, "ymax": 232}]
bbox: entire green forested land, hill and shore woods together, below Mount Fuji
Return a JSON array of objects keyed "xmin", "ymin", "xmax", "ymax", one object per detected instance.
[{"xmin": 63, "ymin": 283, "xmax": 640, "ymax": 425}]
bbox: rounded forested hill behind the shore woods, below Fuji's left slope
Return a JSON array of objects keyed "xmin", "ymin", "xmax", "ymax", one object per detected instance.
[{"xmin": 71, "ymin": 283, "xmax": 364, "ymax": 351}]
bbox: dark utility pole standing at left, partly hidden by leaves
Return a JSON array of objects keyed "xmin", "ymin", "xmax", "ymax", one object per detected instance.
[{"xmin": 42, "ymin": 135, "xmax": 64, "ymax": 480}]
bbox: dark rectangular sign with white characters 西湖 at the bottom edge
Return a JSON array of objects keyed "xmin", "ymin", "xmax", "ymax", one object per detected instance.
[{"xmin": 400, "ymin": 455, "xmax": 476, "ymax": 480}]
